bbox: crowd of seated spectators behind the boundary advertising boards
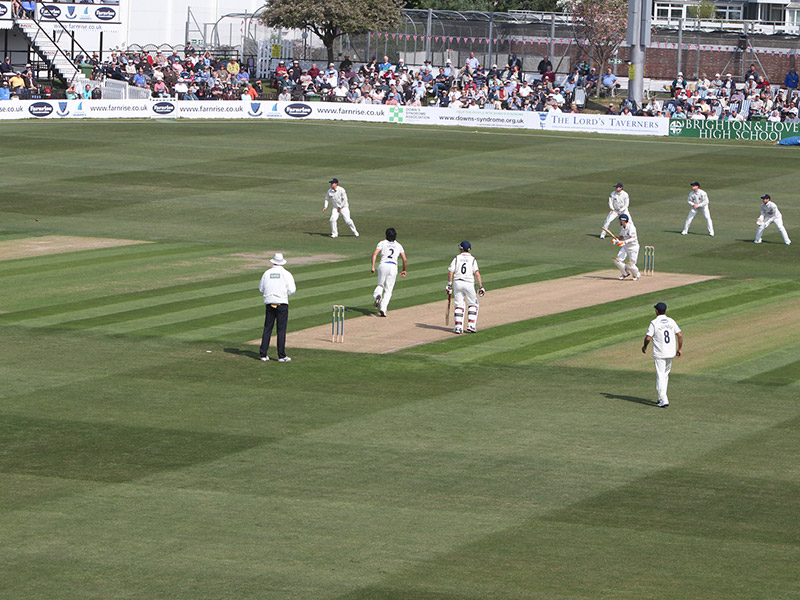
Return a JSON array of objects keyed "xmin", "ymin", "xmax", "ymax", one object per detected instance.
[{"xmin": 0, "ymin": 44, "xmax": 800, "ymax": 122}]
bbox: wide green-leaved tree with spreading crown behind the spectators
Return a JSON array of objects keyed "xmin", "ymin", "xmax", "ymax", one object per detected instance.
[{"xmin": 260, "ymin": 0, "xmax": 403, "ymax": 62}]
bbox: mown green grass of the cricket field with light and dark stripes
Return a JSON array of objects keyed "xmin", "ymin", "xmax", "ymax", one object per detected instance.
[{"xmin": 0, "ymin": 120, "xmax": 800, "ymax": 600}]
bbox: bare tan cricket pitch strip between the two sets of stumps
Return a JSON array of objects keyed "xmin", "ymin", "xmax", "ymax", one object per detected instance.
[{"xmin": 264, "ymin": 271, "xmax": 714, "ymax": 354}]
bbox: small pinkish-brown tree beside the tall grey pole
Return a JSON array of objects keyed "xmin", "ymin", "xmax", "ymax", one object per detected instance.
[{"xmin": 569, "ymin": 0, "xmax": 628, "ymax": 93}]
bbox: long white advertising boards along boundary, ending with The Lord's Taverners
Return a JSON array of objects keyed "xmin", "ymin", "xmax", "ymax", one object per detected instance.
[{"xmin": 0, "ymin": 99, "xmax": 669, "ymax": 136}]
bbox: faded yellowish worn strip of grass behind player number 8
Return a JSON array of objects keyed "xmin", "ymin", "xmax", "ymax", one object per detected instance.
[{"xmin": 556, "ymin": 299, "xmax": 800, "ymax": 374}]
